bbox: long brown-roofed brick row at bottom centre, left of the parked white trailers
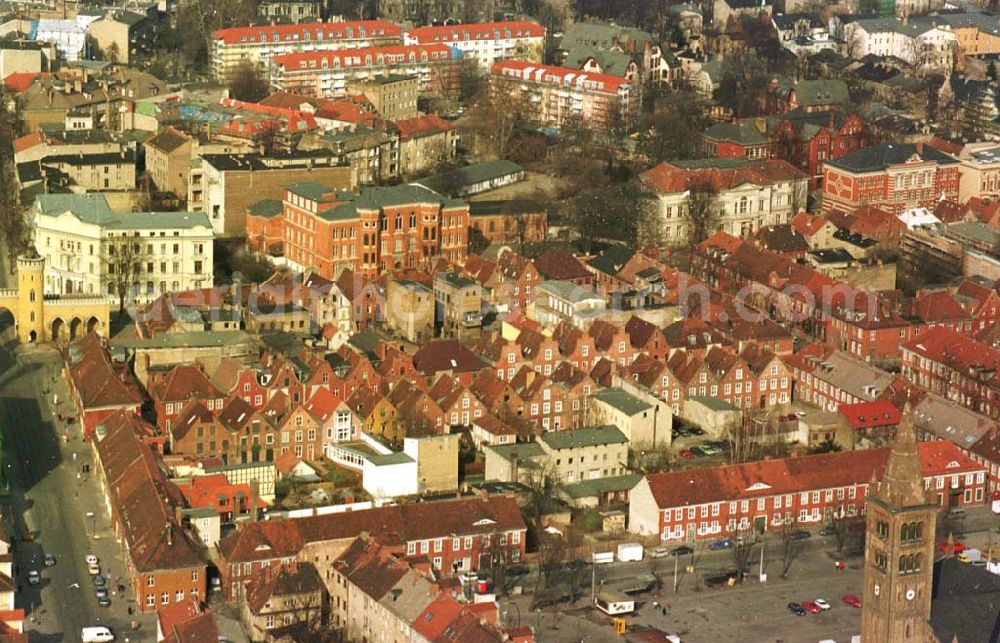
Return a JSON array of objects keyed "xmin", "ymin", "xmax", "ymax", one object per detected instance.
[{"xmin": 215, "ymin": 496, "xmax": 527, "ymax": 600}]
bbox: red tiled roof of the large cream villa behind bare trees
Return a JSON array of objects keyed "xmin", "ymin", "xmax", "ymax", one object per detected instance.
[{"xmin": 639, "ymin": 159, "xmax": 806, "ymax": 194}]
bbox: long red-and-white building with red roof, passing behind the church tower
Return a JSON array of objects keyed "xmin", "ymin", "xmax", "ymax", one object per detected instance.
[{"xmin": 629, "ymin": 432, "xmax": 986, "ymax": 542}]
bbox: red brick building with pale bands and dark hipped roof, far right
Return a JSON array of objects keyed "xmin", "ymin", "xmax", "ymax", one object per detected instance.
[{"xmin": 823, "ymin": 143, "xmax": 959, "ymax": 214}]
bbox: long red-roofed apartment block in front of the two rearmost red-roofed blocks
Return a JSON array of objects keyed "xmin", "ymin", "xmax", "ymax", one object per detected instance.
[{"xmin": 270, "ymin": 44, "xmax": 462, "ymax": 98}]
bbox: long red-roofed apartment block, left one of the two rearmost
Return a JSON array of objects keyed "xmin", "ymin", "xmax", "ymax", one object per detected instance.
[{"xmin": 211, "ymin": 20, "xmax": 402, "ymax": 80}]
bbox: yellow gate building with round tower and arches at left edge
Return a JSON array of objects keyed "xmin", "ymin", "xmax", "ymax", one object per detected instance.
[{"xmin": 0, "ymin": 248, "xmax": 111, "ymax": 344}]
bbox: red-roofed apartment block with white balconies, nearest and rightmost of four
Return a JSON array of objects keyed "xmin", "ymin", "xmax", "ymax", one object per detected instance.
[{"xmin": 490, "ymin": 60, "xmax": 639, "ymax": 129}]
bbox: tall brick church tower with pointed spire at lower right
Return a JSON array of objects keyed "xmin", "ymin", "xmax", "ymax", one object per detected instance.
[{"xmin": 861, "ymin": 402, "xmax": 938, "ymax": 643}]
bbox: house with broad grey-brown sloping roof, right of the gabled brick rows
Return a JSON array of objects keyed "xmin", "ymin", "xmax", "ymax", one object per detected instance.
[{"xmin": 782, "ymin": 344, "xmax": 893, "ymax": 411}]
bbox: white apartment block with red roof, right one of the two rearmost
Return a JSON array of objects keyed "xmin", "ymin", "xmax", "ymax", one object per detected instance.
[{"xmin": 404, "ymin": 20, "xmax": 545, "ymax": 72}]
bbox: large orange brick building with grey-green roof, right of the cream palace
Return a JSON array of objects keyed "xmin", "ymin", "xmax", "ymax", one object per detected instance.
[{"xmin": 247, "ymin": 183, "xmax": 469, "ymax": 279}]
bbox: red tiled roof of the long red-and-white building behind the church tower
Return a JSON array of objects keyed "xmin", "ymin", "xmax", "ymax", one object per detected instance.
[{"xmin": 646, "ymin": 440, "xmax": 983, "ymax": 509}]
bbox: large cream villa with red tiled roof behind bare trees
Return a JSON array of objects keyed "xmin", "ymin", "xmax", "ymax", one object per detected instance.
[{"xmin": 640, "ymin": 159, "xmax": 809, "ymax": 245}]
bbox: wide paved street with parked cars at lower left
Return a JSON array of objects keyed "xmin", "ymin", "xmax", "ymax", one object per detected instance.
[{"xmin": 0, "ymin": 331, "xmax": 155, "ymax": 641}]
